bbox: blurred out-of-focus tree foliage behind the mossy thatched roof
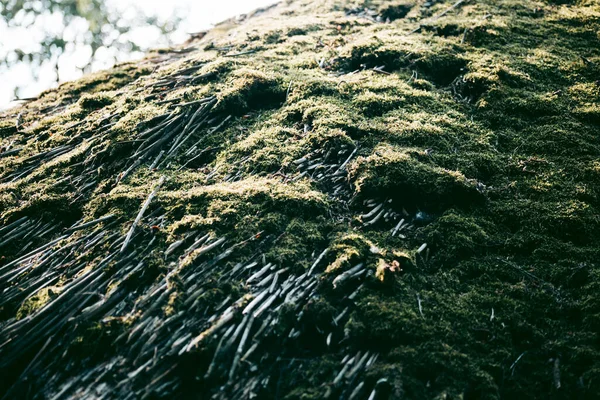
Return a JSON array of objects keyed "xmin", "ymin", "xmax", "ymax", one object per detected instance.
[{"xmin": 0, "ymin": 0, "xmax": 181, "ymax": 92}]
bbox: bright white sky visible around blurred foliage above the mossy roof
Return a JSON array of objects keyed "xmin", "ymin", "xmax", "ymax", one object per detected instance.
[{"xmin": 0, "ymin": 0, "xmax": 277, "ymax": 109}]
